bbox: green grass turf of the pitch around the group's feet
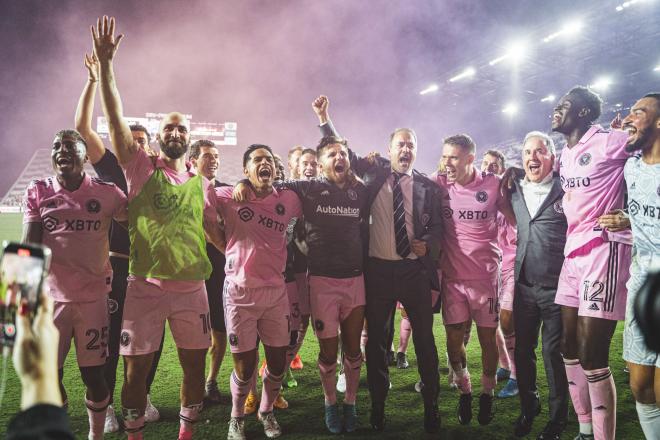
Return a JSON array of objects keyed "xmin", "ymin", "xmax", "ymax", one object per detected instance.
[{"xmin": 0, "ymin": 214, "xmax": 644, "ymax": 440}]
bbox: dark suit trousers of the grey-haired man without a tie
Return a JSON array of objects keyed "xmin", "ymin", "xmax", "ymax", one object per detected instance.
[{"xmin": 513, "ymin": 277, "xmax": 568, "ymax": 424}]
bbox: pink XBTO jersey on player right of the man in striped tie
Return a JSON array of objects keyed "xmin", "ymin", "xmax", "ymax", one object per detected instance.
[{"xmin": 432, "ymin": 169, "xmax": 500, "ymax": 280}]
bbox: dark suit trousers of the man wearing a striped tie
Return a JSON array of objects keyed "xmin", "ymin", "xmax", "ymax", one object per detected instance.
[{"xmin": 365, "ymin": 258, "xmax": 439, "ymax": 404}]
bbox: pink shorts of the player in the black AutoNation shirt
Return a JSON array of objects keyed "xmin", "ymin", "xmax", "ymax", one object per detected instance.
[{"xmin": 309, "ymin": 275, "xmax": 366, "ymax": 339}]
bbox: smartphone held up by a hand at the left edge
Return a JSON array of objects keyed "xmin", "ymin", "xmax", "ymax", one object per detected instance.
[{"xmin": 0, "ymin": 243, "xmax": 48, "ymax": 346}]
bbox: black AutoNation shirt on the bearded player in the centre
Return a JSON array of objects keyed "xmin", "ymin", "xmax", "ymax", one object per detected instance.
[{"xmin": 281, "ymin": 177, "xmax": 368, "ymax": 278}]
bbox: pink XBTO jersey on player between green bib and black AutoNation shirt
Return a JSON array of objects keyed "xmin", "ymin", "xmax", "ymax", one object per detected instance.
[{"xmin": 215, "ymin": 186, "xmax": 302, "ymax": 288}]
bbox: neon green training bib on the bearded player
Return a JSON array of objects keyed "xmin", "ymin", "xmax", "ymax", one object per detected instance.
[{"xmin": 128, "ymin": 168, "xmax": 211, "ymax": 280}]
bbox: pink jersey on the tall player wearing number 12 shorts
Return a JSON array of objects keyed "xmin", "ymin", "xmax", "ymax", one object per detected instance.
[{"xmin": 559, "ymin": 125, "xmax": 632, "ymax": 256}]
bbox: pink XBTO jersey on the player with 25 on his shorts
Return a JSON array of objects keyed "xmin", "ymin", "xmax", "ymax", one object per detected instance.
[{"xmin": 23, "ymin": 175, "xmax": 127, "ymax": 302}]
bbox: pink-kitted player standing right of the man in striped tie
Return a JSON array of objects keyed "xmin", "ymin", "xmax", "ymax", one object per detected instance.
[{"xmin": 432, "ymin": 134, "xmax": 515, "ymax": 425}]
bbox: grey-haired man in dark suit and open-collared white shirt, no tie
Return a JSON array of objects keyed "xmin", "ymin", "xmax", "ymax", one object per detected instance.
[{"xmin": 502, "ymin": 131, "xmax": 568, "ymax": 439}]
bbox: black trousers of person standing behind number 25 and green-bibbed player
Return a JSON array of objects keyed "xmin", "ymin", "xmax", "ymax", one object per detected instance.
[{"xmin": 105, "ymin": 257, "xmax": 165, "ymax": 403}]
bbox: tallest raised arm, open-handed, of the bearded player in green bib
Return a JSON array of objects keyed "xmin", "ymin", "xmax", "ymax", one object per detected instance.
[{"xmin": 90, "ymin": 16, "xmax": 137, "ymax": 164}]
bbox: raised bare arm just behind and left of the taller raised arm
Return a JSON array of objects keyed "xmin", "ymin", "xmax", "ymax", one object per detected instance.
[{"xmin": 75, "ymin": 53, "xmax": 105, "ymax": 165}]
